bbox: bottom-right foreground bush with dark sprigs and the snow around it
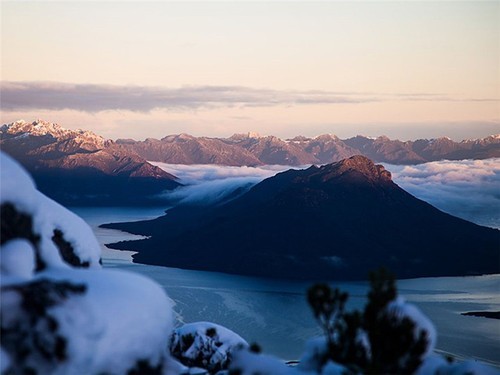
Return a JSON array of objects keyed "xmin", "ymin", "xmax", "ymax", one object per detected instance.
[{"xmin": 230, "ymin": 271, "xmax": 498, "ymax": 375}]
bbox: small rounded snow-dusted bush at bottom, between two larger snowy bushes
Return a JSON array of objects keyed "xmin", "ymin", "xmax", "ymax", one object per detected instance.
[{"xmin": 170, "ymin": 322, "xmax": 248, "ymax": 373}]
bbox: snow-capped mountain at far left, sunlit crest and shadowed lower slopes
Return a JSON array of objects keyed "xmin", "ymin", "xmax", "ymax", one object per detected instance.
[{"xmin": 0, "ymin": 120, "xmax": 179, "ymax": 205}]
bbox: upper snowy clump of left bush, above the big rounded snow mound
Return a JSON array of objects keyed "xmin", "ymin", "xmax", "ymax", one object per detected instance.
[{"xmin": 0, "ymin": 153, "xmax": 101, "ymax": 271}]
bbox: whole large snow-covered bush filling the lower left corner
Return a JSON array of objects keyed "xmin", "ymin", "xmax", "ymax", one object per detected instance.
[{"xmin": 0, "ymin": 153, "xmax": 181, "ymax": 374}]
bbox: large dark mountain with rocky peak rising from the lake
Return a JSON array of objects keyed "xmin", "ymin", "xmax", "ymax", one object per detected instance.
[{"xmin": 105, "ymin": 156, "xmax": 500, "ymax": 279}]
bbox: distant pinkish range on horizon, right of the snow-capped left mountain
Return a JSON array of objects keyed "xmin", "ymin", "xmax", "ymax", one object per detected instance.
[{"xmin": 116, "ymin": 133, "xmax": 500, "ymax": 166}]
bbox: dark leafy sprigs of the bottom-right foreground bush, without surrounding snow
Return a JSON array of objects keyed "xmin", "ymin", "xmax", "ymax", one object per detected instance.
[{"xmin": 307, "ymin": 269, "xmax": 428, "ymax": 374}]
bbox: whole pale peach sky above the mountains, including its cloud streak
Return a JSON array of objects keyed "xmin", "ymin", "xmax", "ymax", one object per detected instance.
[{"xmin": 1, "ymin": 1, "xmax": 500, "ymax": 139}]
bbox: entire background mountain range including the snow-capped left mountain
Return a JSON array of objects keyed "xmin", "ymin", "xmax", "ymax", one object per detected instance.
[{"xmin": 0, "ymin": 120, "xmax": 500, "ymax": 205}]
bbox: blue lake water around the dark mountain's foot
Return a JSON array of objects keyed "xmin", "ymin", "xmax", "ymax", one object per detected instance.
[{"xmin": 72, "ymin": 207, "xmax": 500, "ymax": 367}]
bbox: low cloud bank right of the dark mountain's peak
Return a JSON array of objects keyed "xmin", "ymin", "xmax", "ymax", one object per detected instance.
[{"xmin": 385, "ymin": 159, "xmax": 500, "ymax": 228}]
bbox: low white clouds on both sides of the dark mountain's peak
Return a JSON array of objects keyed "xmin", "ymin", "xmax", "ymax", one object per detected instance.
[{"xmin": 154, "ymin": 159, "xmax": 500, "ymax": 228}]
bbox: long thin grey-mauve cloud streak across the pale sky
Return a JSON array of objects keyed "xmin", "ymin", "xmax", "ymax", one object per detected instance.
[{"xmin": 1, "ymin": 81, "xmax": 493, "ymax": 113}]
